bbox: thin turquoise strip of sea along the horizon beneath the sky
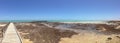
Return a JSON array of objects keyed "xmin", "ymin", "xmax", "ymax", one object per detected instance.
[{"xmin": 0, "ymin": 20, "xmax": 102, "ymax": 22}]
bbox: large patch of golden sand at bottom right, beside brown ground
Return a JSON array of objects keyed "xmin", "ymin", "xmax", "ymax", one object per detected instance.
[{"xmin": 59, "ymin": 33, "xmax": 120, "ymax": 43}]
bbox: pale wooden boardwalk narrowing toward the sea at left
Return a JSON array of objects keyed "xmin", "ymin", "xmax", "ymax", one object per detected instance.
[{"xmin": 2, "ymin": 23, "xmax": 22, "ymax": 43}]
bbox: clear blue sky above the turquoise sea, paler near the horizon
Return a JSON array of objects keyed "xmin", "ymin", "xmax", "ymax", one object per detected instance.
[{"xmin": 0, "ymin": 0, "xmax": 120, "ymax": 20}]
